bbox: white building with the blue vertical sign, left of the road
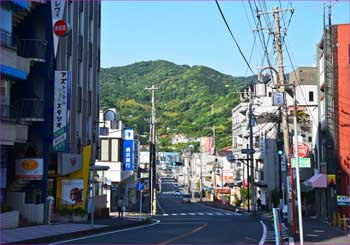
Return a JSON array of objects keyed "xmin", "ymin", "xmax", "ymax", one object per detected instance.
[{"xmin": 96, "ymin": 109, "xmax": 141, "ymax": 212}]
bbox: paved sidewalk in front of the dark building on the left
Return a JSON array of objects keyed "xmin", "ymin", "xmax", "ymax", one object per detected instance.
[{"xmin": 1, "ymin": 217, "xmax": 149, "ymax": 244}]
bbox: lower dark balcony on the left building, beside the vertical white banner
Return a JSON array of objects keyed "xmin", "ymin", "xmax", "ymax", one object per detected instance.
[{"xmin": 15, "ymin": 99, "xmax": 44, "ymax": 122}]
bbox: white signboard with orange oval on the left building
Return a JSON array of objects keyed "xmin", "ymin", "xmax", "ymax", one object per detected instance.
[{"xmin": 16, "ymin": 158, "xmax": 44, "ymax": 180}]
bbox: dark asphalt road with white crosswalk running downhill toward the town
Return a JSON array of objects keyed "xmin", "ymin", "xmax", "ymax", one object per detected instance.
[{"xmin": 53, "ymin": 178, "xmax": 263, "ymax": 244}]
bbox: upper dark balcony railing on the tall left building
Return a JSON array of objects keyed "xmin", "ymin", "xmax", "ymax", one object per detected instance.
[{"xmin": 17, "ymin": 39, "xmax": 47, "ymax": 62}]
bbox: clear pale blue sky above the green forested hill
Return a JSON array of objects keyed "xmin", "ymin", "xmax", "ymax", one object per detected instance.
[{"xmin": 101, "ymin": 1, "xmax": 350, "ymax": 76}]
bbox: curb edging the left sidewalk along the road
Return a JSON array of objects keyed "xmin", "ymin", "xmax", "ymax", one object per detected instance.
[{"xmin": 6, "ymin": 220, "xmax": 149, "ymax": 244}]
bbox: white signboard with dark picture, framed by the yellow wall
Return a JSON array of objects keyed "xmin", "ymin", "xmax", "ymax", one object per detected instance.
[{"xmin": 62, "ymin": 179, "xmax": 84, "ymax": 205}]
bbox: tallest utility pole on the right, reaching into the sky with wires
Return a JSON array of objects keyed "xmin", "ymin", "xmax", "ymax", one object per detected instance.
[{"xmin": 273, "ymin": 7, "xmax": 296, "ymax": 238}]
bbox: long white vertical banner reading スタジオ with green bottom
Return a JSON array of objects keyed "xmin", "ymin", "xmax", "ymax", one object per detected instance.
[{"xmin": 53, "ymin": 71, "xmax": 71, "ymax": 152}]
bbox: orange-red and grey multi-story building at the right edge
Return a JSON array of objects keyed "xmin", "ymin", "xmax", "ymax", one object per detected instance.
[{"xmin": 317, "ymin": 24, "xmax": 350, "ymax": 219}]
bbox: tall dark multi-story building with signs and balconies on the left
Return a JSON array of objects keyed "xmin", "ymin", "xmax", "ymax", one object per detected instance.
[{"xmin": 1, "ymin": 0, "xmax": 101, "ymax": 226}]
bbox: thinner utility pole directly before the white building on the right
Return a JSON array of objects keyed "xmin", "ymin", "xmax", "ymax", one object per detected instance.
[{"xmin": 248, "ymin": 84, "xmax": 255, "ymax": 212}]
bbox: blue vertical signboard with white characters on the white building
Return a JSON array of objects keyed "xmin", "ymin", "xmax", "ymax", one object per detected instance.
[{"xmin": 123, "ymin": 128, "xmax": 134, "ymax": 171}]
